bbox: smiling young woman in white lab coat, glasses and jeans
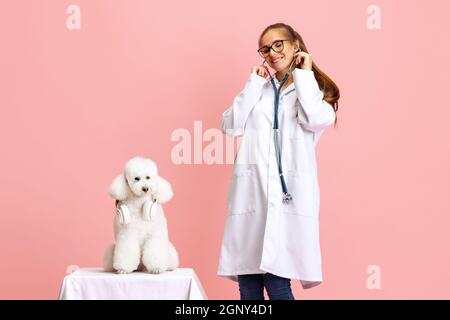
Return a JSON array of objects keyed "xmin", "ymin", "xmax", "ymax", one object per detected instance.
[{"xmin": 218, "ymin": 23, "xmax": 339, "ymax": 300}]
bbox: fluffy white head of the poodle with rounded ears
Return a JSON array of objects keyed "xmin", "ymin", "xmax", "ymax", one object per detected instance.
[{"xmin": 109, "ymin": 157, "xmax": 173, "ymax": 203}]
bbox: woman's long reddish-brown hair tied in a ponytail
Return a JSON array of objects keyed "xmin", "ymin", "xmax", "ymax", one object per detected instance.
[{"xmin": 258, "ymin": 23, "xmax": 340, "ymax": 127}]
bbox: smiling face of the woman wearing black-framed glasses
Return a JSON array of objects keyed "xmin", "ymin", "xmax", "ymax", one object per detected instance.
[{"xmin": 260, "ymin": 29, "xmax": 299, "ymax": 72}]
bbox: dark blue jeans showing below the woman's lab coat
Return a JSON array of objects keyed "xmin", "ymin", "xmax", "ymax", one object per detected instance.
[{"xmin": 238, "ymin": 273, "xmax": 295, "ymax": 300}]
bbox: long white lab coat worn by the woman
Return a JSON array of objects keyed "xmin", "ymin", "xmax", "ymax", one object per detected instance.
[{"xmin": 217, "ymin": 68, "xmax": 335, "ymax": 289}]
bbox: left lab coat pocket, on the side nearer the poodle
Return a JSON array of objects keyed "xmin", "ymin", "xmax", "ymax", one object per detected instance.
[{"xmin": 227, "ymin": 168, "xmax": 257, "ymax": 216}]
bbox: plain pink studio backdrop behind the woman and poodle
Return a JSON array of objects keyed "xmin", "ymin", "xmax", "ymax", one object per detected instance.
[{"xmin": 0, "ymin": 0, "xmax": 450, "ymax": 299}]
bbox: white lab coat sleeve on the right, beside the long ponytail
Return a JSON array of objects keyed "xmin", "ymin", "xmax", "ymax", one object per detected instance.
[{"xmin": 293, "ymin": 68, "xmax": 336, "ymax": 132}]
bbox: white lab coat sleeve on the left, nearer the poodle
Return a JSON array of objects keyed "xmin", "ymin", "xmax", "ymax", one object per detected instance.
[{"xmin": 222, "ymin": 73, "xmax": 267, "ymax": 136}]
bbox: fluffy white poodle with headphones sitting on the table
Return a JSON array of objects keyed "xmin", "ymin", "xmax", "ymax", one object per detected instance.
[{"xmin": 104, "ymin": 157, "xmax": 179, "ymax": 274}]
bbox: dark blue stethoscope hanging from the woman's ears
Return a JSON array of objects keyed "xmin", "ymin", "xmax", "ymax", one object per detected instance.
[{"xmin": 262, "ymin": 48, "xmax": 301, "ymax": 203}]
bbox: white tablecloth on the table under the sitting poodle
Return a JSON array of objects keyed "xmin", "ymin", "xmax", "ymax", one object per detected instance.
[{"xmin": 59, "ymin": 268, "xmax": 207, "ymax": 300}]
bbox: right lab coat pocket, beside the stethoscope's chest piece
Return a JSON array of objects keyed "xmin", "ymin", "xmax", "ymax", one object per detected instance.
[{"xmin": 283, "ymin": 170, "xmax": 317, "ymax": 218}]
